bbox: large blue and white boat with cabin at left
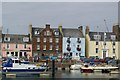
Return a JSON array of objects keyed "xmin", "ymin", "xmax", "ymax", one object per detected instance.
[{"xmin": 2, "ymin": 58, "xmax": 47, "ymax": 72}]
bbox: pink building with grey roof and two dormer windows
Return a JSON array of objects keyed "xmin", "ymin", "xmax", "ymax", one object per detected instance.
[{"xmin": 1, "ymin": 34, "xmax": 32, "ymax": 59}]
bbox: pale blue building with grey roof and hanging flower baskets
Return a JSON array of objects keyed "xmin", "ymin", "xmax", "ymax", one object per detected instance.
[{"xmin": 62, "ymin": 26, "xmax": 85, "ymax": 60}]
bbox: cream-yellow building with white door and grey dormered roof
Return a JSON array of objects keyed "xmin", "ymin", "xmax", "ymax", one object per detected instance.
[{"xmin": 85, "ymin": 26, "xmax": 119, "ymax": 59}]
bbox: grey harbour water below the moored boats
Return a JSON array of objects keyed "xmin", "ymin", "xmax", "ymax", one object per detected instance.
[{"xmin": 1, "ymin": 70, "xmax": 120, "ymax": 80}]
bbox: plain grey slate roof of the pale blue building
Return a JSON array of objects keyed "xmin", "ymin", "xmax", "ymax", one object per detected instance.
[{"xmin": 62, "ymin": 28, "xmax": 84, "ymax": 37}]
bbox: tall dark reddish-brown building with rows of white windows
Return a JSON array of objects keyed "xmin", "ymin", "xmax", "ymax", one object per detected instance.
[{"xmin": 29, "ymin": 24, "xmax": 62, "ymax": 58}]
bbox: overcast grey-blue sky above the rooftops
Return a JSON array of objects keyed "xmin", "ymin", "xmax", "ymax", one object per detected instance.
[{"xmin": 0, "ymin": 0, "xmax": 118, "ymax": 34}]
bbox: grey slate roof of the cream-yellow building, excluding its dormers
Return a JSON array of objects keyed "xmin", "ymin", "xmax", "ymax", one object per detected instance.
[{"xmin": 89, "ymin": 32, "xmax": 115, "ymax": 41}]
